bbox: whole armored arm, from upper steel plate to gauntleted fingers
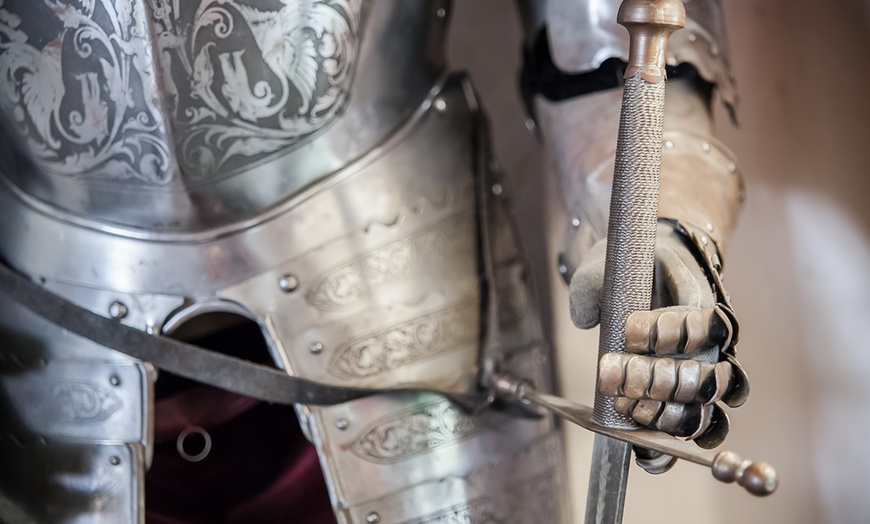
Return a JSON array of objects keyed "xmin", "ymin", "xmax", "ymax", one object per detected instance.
[{"xmin": 521, "ymin": 0, "xmax": 748, "ymax": 446}]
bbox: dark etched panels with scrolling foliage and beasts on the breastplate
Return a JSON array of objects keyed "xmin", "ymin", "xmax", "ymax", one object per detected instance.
[{"xmin": 0, "ymin": 0, "xmax": 362, "ymax": 185}]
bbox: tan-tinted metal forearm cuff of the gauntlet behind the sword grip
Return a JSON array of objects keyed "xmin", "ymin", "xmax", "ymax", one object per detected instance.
[{"xmin": 535, "ymin": 77, "xmax": 745, "ymax": 279}]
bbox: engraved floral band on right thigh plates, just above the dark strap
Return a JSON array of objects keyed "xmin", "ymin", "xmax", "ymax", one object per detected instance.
[{"xmin": 329, "ymin": 303, "xmax": 479, "ymax": 379}]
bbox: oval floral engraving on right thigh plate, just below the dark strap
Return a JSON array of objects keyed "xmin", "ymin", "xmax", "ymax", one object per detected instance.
[{"xmin": 353, "ymin": 400, "xmax": 489, "ymax": 464}]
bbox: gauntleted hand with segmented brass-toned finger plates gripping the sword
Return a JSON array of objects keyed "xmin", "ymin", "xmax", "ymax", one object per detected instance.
[{"xmin": 570, "ymin": 221, "xmax": 749, "ymax": 447}]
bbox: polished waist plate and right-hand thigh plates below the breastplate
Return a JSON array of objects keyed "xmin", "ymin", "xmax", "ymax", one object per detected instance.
[{"xmin": 0, "ymin": 73, "xmax": 570, "ymax": 523}]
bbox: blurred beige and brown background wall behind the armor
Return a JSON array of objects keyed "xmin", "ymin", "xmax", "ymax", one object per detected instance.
[{"xmin": 450, "ymin": 0, "xmax": 870, "ymax": 524}]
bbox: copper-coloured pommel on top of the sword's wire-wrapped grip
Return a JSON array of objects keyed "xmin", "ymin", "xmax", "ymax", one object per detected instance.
[{"xmin": 616, "ymin": 0, "xmax": 686, "ymax": 84}]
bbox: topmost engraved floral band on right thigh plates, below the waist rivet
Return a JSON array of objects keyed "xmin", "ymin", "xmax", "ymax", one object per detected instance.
[{"xmin": 306, "ymin": 215, "xmax": 474, "ymax": 311}]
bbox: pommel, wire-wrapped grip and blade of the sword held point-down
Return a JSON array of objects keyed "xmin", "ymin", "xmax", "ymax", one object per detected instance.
[{"xmin": 586, "ymin": 0, "xmax": 686, "ymax": 524}]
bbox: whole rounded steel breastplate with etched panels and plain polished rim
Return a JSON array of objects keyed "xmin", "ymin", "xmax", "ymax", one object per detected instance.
[{"xmin": 0, "ymin": 0, "xmax": 454, "ymax": 229}]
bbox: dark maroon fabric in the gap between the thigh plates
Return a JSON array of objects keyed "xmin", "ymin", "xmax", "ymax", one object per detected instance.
[{"xmin": 145, "ymin": 386, "xmax": 335, "ymax": 524}]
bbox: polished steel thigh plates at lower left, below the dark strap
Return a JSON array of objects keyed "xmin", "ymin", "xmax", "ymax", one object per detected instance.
[{"xmin": 0, "ymin": 299, "xmax": 154, "ymax": 524}]
